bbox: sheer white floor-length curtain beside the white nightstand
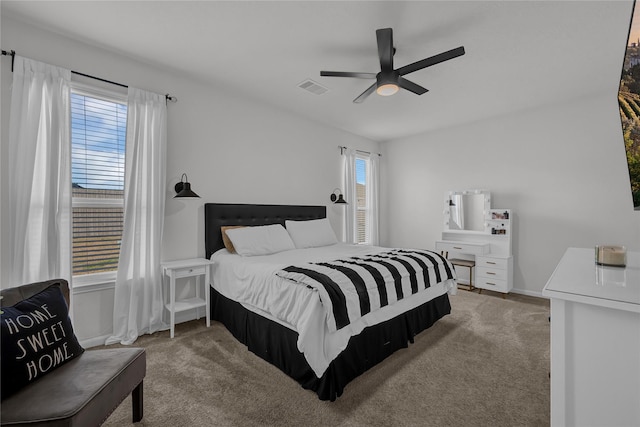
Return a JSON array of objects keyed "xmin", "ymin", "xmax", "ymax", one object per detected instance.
[{"xmin": 106, "ymin": 87, "xmax": 167, "ymax": 344}]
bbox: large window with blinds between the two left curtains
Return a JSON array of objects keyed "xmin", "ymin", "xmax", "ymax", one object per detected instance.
[{"xmin": 71, "ymin": 85, "xmax": 127, "ymax": 276}]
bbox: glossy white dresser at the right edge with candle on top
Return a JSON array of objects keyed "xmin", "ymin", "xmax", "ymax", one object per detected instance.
[{"xmin": 542, "ymin": 248, "xmax": 640, "ymax": 426}]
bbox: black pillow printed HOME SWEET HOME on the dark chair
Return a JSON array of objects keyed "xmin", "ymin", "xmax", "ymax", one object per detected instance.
[{"xmin": 0, "ymin": 284, "xmax": 84, "ymax": 400}]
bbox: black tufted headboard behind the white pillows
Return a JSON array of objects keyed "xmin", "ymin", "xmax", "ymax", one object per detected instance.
[{"xmin": 204, "ymin": 203, "xmax": 327, "ymax": 258}]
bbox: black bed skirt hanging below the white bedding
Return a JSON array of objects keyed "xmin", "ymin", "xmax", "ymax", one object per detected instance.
[{"xmin": 210, "ymin": 288, "xmax": 451, "ymax": 401}]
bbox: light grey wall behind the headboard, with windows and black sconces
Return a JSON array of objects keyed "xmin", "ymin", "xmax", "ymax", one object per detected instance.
[{"xmin": 0, "ymin": 14, "xmax": 379, "ymax": 341}]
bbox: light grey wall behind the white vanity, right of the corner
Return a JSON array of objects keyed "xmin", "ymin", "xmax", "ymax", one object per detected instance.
[{"xmin": 382, "ymin": 93, "xmax": 640, "ymax": 295}]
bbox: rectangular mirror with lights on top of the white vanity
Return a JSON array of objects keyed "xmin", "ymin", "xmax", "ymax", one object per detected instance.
[{"xmin": 444, "ymin": 190, "xmax": 491, "ymax": 233}]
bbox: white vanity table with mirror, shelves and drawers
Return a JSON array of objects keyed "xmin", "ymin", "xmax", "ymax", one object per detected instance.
[{"xmin": 436, "ymin": 190, "xmax": 513, "ymax": 297}]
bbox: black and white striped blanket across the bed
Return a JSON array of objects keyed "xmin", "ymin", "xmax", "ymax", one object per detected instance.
[{"xmin": 276, "ymin": 249, "xmax": 455, "ymax": 331}]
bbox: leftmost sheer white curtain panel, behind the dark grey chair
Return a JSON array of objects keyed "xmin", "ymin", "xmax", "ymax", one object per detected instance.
[{"xmin": 2, "ymin": 56, "xmax": 72, "ymax": 287}]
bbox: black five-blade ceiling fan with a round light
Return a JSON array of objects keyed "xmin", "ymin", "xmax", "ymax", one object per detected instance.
[{"xmin": 320, "ymin": 28, "xmax": 464, "ymax": 104}]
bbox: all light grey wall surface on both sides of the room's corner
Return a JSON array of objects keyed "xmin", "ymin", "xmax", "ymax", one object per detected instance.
[{"xmin": 6, "ymin": 6, "xmax": 640, "ymax": 340}]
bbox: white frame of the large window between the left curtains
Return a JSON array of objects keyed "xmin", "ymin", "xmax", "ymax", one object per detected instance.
[{"xmin": 69, "ymin": 82, "xmax": 128, "ymax": 286}]
